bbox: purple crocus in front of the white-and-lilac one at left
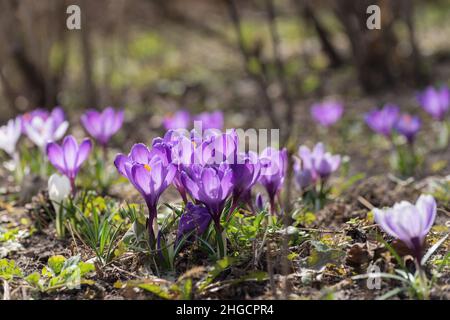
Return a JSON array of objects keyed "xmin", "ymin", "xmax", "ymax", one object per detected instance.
[{"xmin": 47, "ymin": 135, "xmax": 92, "ymax": 191}]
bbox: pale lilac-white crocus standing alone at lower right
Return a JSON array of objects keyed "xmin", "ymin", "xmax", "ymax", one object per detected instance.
[{"xmin": 373, "ymin": 195, "xmax": 436, "ymax": 263}]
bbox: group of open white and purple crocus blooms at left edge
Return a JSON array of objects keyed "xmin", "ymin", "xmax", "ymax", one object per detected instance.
[{"xmin": 0, "ymin": 107, "xmax": 123, "ymax": 190}]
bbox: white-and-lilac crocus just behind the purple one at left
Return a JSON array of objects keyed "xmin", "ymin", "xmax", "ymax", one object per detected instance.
[{"xmin": 22, "ymin": 107, "xmax": 69, "ymax": 150}]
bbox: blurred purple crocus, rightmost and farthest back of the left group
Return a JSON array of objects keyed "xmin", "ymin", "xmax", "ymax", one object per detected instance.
[{"xmin": 81, "ymin": 107, "xmax": 123, "ymax": 147}]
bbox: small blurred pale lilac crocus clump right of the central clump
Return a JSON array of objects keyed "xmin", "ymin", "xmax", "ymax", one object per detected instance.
[{"xmin": 294, "ymin": 142, "xmax": 341, "ymax": 210}]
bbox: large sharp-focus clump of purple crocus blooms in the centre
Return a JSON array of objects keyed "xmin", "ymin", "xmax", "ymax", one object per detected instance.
[{"xmin": 111, "ymin": 130, "xmax": 287, "ymax": 245}]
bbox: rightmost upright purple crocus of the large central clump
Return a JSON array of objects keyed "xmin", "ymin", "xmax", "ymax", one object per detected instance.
[{"xmin": 259, "ymin": 147, "xmax": 287, "ymax": 214}]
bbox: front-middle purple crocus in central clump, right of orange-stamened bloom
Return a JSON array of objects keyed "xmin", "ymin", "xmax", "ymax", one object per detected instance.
[{"xmin": 181, "ymin": 164, "xmax": 233, "ymax": 233}]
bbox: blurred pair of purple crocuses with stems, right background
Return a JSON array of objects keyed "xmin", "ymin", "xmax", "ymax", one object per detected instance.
[{"xmin": 365, "ymin": 104, "xmax": 422, "ymax": 177}]
